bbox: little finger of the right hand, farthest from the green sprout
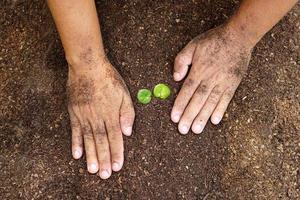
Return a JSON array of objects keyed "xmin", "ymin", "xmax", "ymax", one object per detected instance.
[{"xmin": 211, "ymin": 88, "xmax": 236, "ymax": 125}]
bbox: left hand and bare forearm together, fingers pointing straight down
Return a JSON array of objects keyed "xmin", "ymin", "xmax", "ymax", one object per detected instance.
[{"xmin": 48, "ymin": 0, "xmax": 135, "ymax": 179}]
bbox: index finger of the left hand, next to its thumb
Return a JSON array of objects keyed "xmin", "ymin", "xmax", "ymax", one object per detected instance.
[{"xmin": 105, "ymin": 114, "xmax": 124, "ymax": 171}]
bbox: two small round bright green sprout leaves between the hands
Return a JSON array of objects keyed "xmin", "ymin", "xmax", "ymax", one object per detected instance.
[{"xmin": 137, "ymin": 83, "xmax": 171, "ymax": 104}]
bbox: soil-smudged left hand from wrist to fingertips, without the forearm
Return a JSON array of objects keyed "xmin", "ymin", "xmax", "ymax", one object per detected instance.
[{"xmin": 68, "ymin": 58, "xmax": 135, "ymax": 179}]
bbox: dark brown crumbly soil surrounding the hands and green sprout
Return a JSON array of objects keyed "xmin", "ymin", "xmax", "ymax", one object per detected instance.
[{"xmin": 0, "ymin": 0, "xmax": 300, "ymax": 200}]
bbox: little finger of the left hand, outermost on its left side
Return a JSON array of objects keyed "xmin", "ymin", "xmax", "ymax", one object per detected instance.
[{"xmin": 69, "ymin": 110, "xmax": 83, "ymax": 159}]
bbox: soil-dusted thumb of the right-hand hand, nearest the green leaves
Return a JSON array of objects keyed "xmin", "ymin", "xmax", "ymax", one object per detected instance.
[{"xmin": 173, "ymin": 42, "xmax": 196, "ymax": 81}]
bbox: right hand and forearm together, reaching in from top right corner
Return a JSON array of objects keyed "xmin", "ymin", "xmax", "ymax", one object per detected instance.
[{"xmin": 171, "ymin": 0, "xmax": 297, "ymax": 134}]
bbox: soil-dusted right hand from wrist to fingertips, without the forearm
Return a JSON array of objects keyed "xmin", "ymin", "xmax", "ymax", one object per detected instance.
[{"xmin": 171, "ymin": 26, "xmax": 252, "ymax": 134}]
